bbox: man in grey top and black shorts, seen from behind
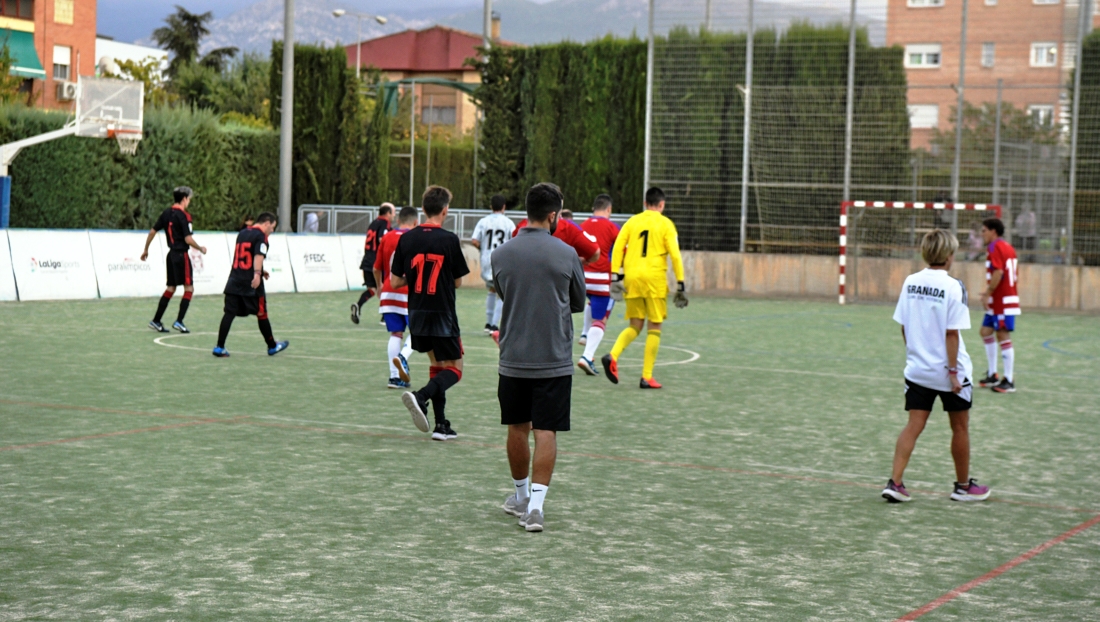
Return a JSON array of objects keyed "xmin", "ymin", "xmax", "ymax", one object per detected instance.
[{"xmin": 492, "ymin": 184, "xmax": 584, "ymax": 532}]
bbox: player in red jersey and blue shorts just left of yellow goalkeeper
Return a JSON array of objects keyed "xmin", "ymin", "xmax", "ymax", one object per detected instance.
[{"xmin": 576, "ymin": 195, "xmax": 618, "ymax": 375}]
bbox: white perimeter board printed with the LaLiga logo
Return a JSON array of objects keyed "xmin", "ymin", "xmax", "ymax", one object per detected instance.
[{"xmin": 8, "ymin": 229, "xmax": 99, "ymax": 301}]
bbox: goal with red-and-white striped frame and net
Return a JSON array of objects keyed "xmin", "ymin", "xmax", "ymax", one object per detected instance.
[{"xmin": 839, "ymin": 200, "xmax": 1001, "ymax": 305}]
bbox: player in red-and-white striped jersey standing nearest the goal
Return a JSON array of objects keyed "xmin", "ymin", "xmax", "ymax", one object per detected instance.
[{"xmin": 979, "ymin": 218, "xmax": 1020, "ymax": 393}]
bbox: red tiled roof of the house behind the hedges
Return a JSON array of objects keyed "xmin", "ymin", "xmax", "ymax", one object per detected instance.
[{"xmin": 347, "ymin": 25, "xmax": 514, "ymax": 72}]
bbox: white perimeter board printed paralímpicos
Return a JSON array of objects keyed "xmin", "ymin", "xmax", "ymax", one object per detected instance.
[{"xmin": 88, "ymin": 231, "xmax": 167, "ymax": 298}]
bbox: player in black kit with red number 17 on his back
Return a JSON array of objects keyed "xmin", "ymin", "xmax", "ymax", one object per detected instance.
[{"xmin": 389, "ymin": 186, "xmax": 470, "ymax": 440}]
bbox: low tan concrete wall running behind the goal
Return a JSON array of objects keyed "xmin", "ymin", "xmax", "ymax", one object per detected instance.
[{"xmin": 463, "ymin": 244, "xmax": 1100, "ymax": 313}]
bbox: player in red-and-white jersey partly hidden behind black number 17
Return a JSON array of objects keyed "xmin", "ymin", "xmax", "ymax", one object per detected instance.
[{"xmin": 374, "ymin": 207, "xmax": 417, "ymax": 389}]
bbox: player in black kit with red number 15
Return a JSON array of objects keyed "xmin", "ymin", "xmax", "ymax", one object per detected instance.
[{"xmin": 213, "ymin": 211, "xmax": 290, "ymax": 358}]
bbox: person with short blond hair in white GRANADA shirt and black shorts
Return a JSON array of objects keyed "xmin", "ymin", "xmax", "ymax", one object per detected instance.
[{"xmin": 882, "ymin": 229, "xmax": 989, "ymax": 503}]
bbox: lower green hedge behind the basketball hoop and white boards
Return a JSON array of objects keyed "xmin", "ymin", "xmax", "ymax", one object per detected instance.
[{"xmin": 0, "ymin": 106, "xmax": 278, "ymax": 230}]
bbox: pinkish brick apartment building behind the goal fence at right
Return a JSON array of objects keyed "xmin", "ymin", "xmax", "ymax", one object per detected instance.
[{"xmin": 887, "ymin": 0, "xmax": 1079, "ymax": 148}]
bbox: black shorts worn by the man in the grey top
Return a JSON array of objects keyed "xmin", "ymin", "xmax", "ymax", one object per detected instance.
[{"xmin": 496, "ymin": 375, "xmax": 573, "ymax": 432}]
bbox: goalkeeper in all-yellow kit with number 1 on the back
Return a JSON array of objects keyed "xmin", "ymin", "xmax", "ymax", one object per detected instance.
[{"xmin": 601, "ymin": 188, "xmax": 688, "ymax": 389}]
